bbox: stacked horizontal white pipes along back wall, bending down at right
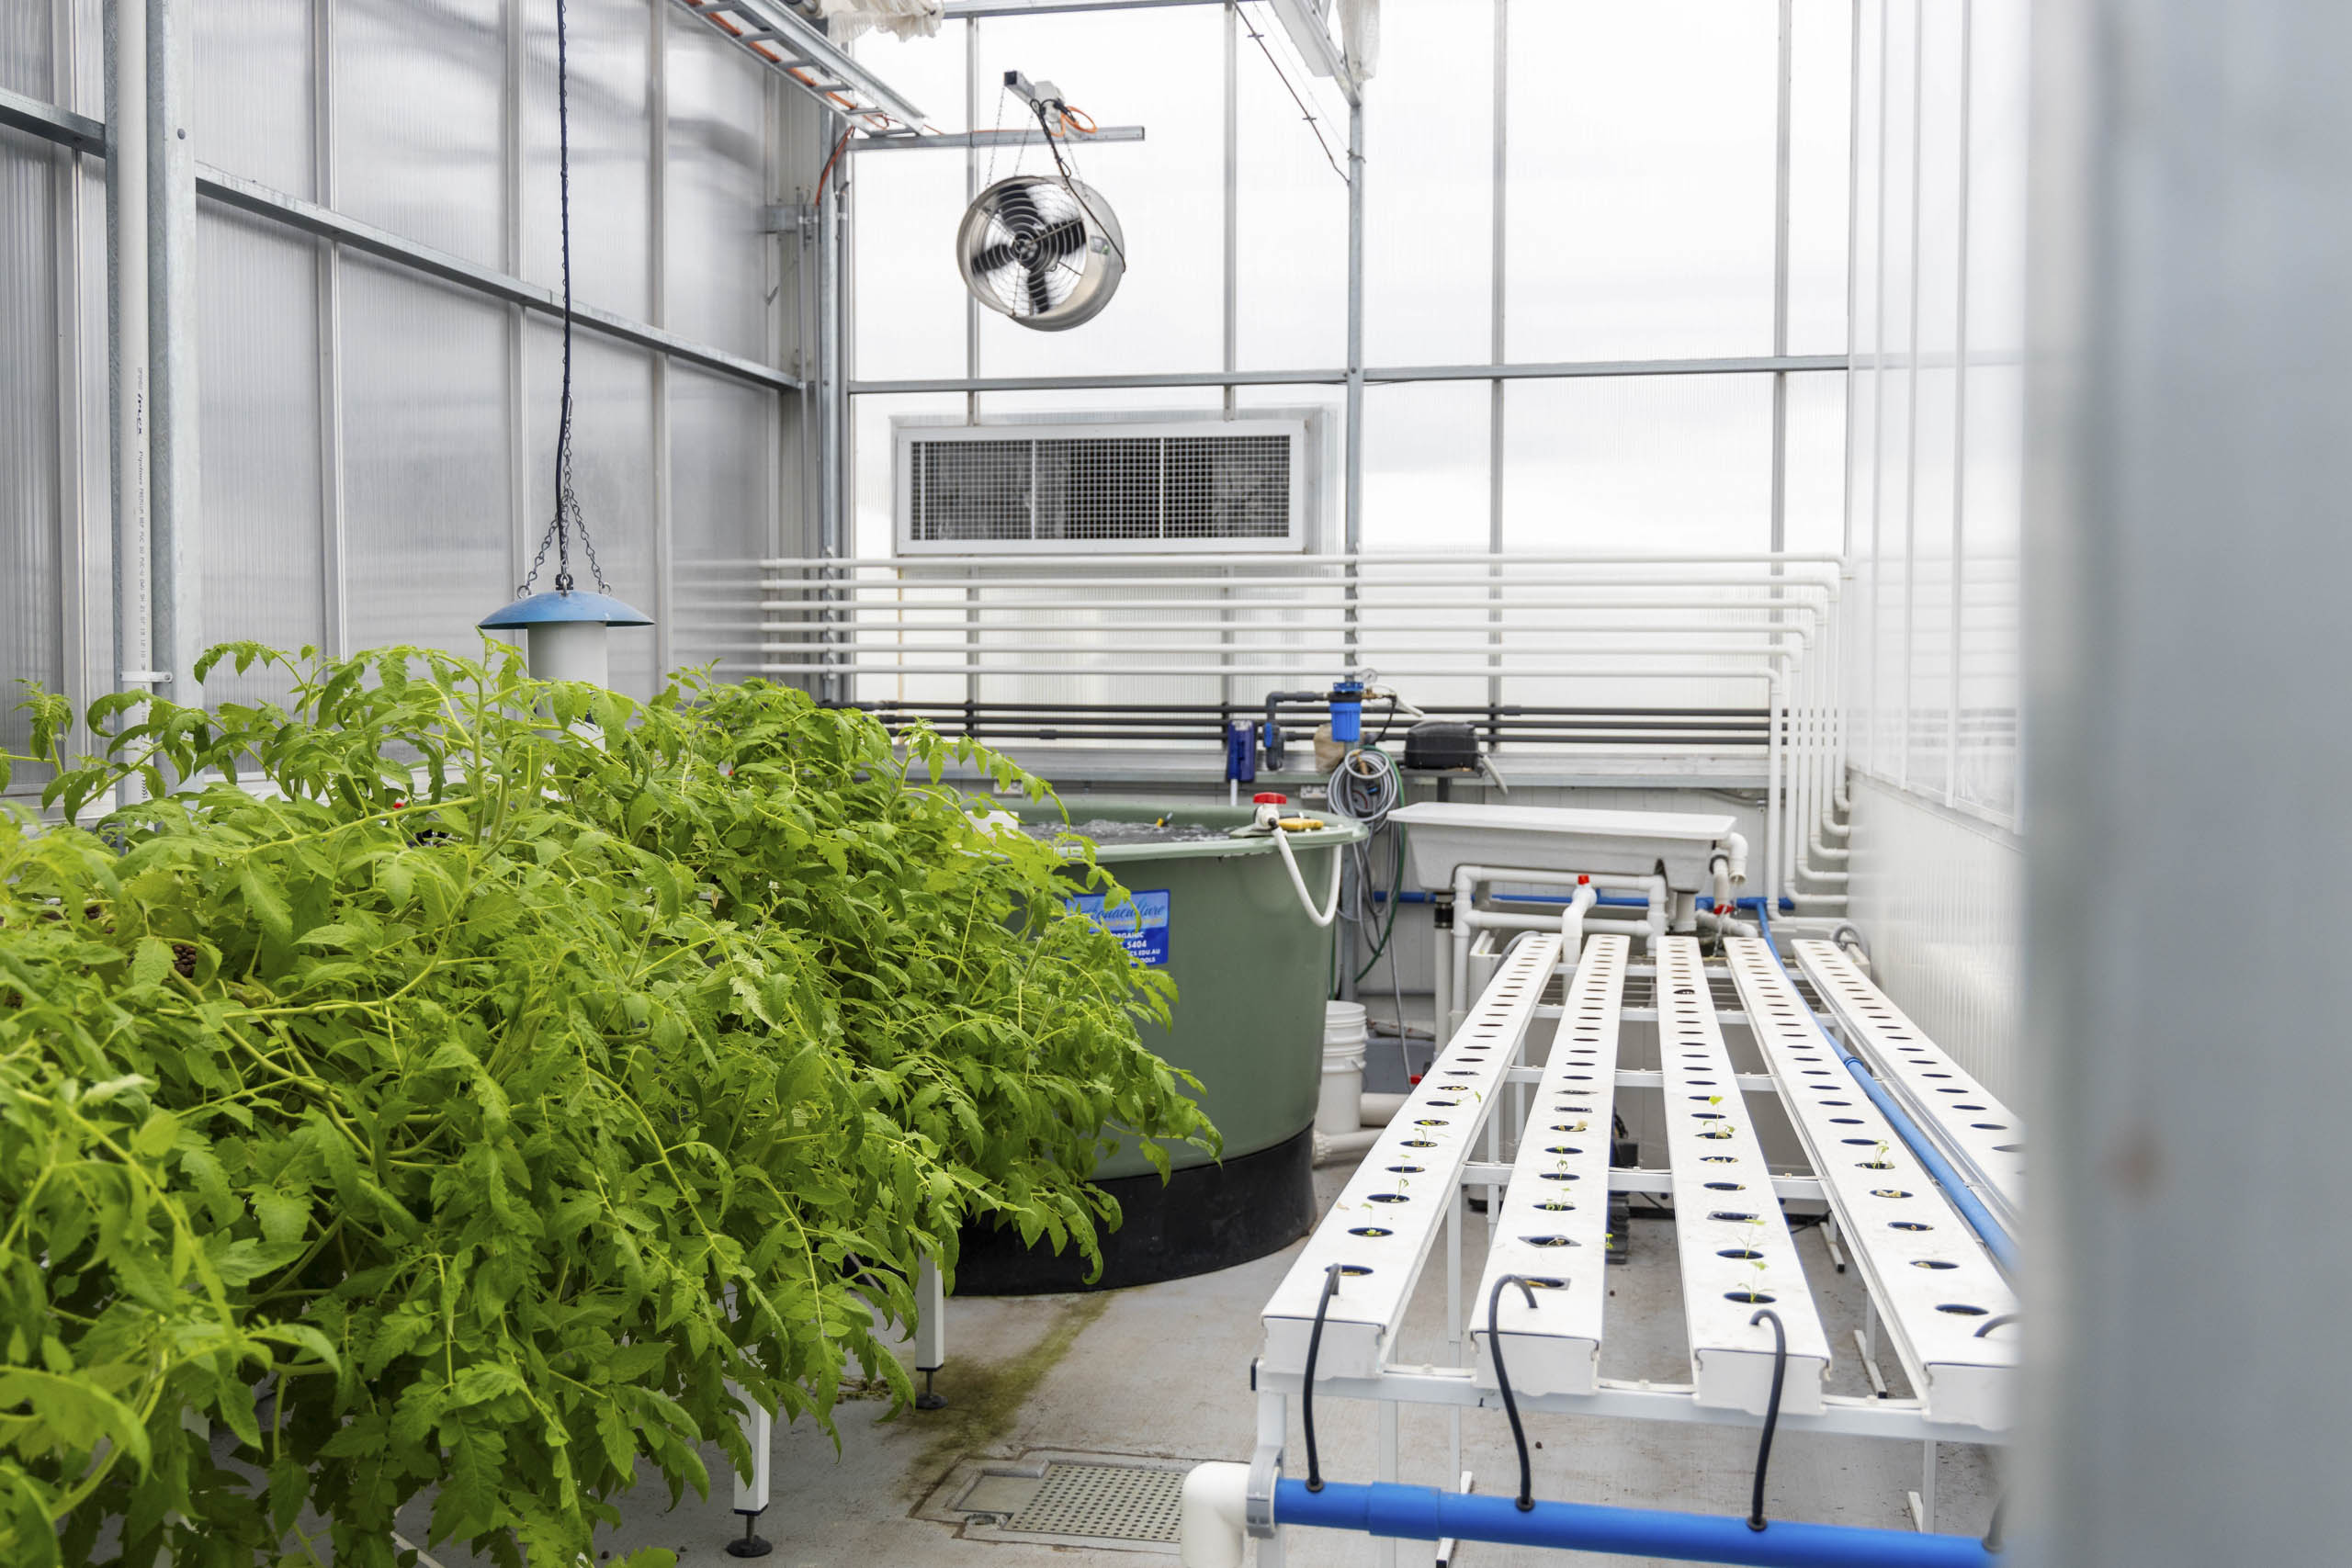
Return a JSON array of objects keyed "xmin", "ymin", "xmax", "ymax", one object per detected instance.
[{"xmin": 677, "ymin": 547, "xmax": 1847, "ymax": 912}]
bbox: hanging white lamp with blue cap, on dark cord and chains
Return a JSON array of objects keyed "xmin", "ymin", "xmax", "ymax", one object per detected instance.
[{"xmin": 478, "ymin": 0, "xmax": 654, "ymax": 686}]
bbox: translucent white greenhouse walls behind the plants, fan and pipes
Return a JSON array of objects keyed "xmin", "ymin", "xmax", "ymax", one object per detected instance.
[{"xmin": 0, "ymin": 0, "xmax": 2025, "ymax": 1086}]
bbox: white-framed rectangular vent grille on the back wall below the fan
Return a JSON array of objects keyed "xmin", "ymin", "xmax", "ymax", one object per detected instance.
[{"xmin": 899, "ymin": 419, "xmax": 1307, "ymax": 555}]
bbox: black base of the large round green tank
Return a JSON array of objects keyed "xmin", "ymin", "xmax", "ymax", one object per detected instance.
[{"xmin": 955, "ymin": 1128, "xmax": 1315, "ymax": 1295}]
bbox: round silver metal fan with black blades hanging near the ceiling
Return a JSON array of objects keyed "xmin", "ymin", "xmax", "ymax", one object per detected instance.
[{"xmin": 955, "ymin": 174, "xmax": 1126, "ymax": 332}]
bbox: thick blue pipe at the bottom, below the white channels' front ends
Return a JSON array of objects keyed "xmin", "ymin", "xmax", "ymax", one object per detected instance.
[{"xmin": 1275, "ymin": 1481, "xmax": 1999, "ymax": 1568}]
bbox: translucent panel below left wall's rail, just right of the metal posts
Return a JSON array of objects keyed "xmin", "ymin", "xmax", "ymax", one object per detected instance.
[{"xmin": 195, "ymin": 207, "xmax": 327, "ymax": 701}]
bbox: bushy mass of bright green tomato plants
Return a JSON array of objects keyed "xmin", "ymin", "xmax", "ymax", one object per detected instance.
[{"xmin": 0, "ymin": 644, "xmax": 1214, "ymax": 1568}]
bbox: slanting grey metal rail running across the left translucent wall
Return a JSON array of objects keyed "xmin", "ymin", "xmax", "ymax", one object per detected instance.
[{"xmin": 0, "ymin": 89, "xmax": 805, "ymax": 392}]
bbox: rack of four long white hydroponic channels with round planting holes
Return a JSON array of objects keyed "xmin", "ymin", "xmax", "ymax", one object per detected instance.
[{"xmin": 1247, "ymin": 933, "xmax": 2016, "ymax": 1568}]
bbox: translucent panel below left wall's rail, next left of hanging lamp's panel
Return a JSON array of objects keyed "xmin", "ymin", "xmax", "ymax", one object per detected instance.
[{"xmin": 344, "ymin": 259, "xmax": 514, "ymax": 653}]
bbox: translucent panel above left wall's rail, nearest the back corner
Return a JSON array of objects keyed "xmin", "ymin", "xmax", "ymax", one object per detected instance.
[{"xmin": 656, "ymin": 0, "xmax": 771, "ymax": 360}]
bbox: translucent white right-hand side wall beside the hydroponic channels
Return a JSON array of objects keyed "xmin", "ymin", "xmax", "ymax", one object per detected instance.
[{"xmin": 1847, "ymin": 0, "xmax": 2028, "ymax": 1093}]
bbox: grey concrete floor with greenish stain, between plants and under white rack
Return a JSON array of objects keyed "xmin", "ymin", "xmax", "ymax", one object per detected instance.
[{"xmin": 412, "ymin": 1166, "xmax": 1999, "ymax": 1568}]
